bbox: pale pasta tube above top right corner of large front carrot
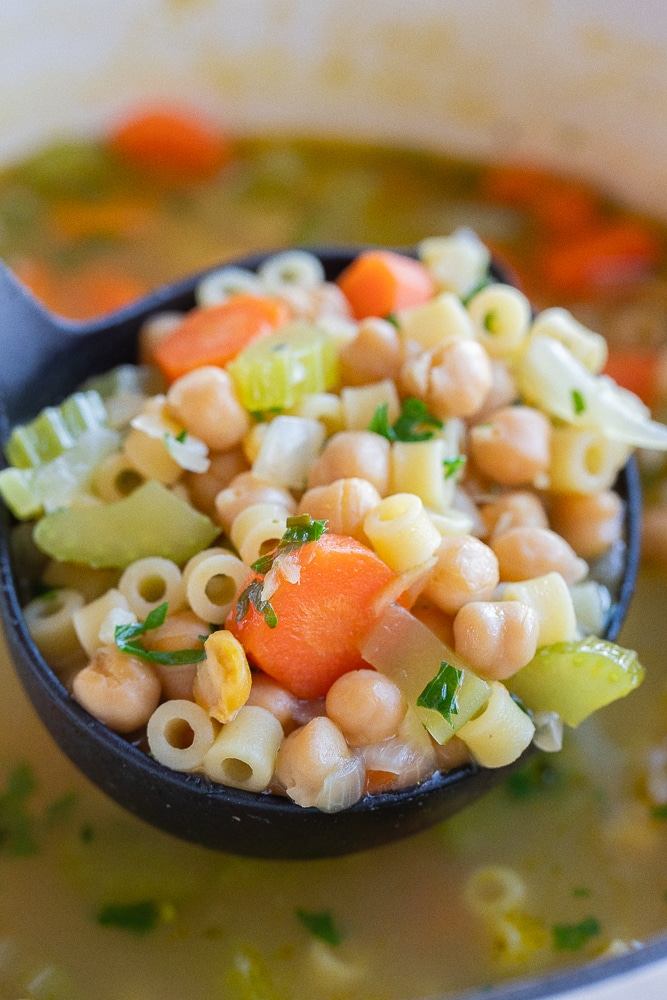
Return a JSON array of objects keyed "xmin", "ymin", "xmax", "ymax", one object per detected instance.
[{"xmin": 364, "ymin": 493, "xmax": 440, "ymax": 573}]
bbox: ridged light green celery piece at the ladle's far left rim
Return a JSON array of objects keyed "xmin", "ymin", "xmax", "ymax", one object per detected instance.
[{"xmin": 5, "ymin": 390, "xmax": 107, "ymax": 469}]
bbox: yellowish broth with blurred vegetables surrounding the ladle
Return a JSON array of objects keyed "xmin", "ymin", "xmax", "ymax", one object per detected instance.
[{"xmin": 0, "ymin": 107, "xmax": 667, "ymax": 1000}]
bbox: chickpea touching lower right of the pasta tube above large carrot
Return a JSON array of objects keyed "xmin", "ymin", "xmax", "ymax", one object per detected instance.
[{"xmin": 424, "ymin": 535, "xmax": 499, "ymax": 614}]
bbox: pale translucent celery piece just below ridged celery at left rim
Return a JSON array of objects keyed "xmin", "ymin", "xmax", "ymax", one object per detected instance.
[{"xmin": 0, "ymin": 426, "xmax": 120, "ymax": 521}]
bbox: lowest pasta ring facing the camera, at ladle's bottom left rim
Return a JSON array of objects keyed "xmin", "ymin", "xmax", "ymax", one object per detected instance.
[{"xmin": 146, "ymin": 698, "xmax": 216, "ymax": 771}]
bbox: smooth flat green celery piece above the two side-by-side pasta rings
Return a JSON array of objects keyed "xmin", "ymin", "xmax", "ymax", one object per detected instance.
[{"xmin": 34, "ymin": 480, "xmax": 220, "ymax": 569}]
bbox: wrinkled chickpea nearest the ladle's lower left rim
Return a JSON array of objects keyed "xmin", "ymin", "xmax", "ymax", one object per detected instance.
[{"xmin": 72, "ymin": 646, "xmax": 161, "ymax": 733}]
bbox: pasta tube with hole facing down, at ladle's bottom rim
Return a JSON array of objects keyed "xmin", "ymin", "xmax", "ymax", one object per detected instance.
[{"xmin": 203, "ymin": 705, "xmax": 283, "ymax": 792}]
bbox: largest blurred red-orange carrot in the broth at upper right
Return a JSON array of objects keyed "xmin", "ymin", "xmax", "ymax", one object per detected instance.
[{"xmin": 539, "ymin": 219, "xmax": 662, "ymax": 298}]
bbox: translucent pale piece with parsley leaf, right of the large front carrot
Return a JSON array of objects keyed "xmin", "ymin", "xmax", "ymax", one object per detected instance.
[{"xmin": 360, "ymin": 604, "xmax": 491, "ymax": 743}]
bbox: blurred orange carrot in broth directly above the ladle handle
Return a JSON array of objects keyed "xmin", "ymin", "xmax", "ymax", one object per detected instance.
[{"xmin": 16, "ymin": 261, "xmax": 148, "ymax": 320}]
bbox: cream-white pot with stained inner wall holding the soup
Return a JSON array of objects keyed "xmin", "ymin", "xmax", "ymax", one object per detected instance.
[{"xmin": 0, "ymin": 0, "xmax": 667, "ymax": 1000}]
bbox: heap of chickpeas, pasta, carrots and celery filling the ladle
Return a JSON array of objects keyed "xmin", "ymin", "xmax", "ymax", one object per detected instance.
[{"xmin": 0, "ymin": 230, "xmax": 667, "ymax": 812}]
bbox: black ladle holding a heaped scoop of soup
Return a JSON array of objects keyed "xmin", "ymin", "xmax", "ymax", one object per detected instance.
[{"xmin": 0, "ymin": 248, "xmax": 641, "ymax": 858}]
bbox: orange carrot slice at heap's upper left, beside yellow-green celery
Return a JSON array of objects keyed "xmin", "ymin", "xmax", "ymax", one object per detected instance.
[{"xmin": 155, "ymin": 294, "xmax": 290, "ymax": 382}]
